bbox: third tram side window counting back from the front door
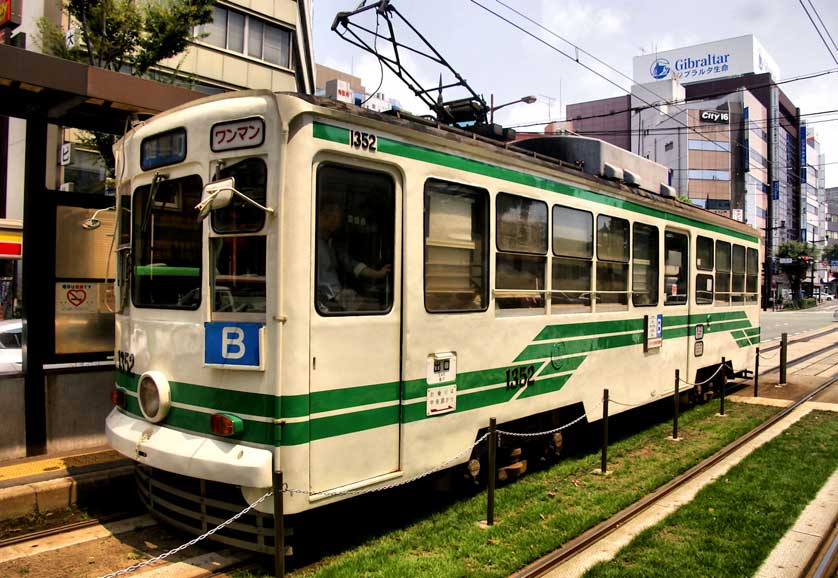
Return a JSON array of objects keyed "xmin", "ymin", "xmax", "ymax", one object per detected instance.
[{"xmin": 550, "ymin": 205, "xmax": 594, "ymax": 313}]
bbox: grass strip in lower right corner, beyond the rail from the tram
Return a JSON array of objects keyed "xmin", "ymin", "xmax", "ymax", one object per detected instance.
[{"xmin": 585, "ymin": 412, "xmax": 838, "ymax": 578}]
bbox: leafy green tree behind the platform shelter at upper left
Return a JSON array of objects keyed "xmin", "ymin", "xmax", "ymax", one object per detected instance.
[{"xmin": 36, "ymin": 0, "xmax": 213, "ymax": 173}]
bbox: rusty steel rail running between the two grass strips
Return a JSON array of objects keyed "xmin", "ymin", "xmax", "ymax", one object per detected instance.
[{"xmin": 512, "ymin": 377, "xmax": 838, "ymax": 578}]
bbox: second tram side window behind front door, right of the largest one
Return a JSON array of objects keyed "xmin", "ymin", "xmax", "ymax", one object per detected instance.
[{"xmin": 495, "ymin": 193, "xmax": 547, "ymax": 309}]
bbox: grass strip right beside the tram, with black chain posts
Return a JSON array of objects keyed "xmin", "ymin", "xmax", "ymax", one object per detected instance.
[{"xmin": 241, "ymin": 404, "xmax": 777, "ymax": 578}]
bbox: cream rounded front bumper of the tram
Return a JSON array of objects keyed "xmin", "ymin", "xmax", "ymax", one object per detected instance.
[{"xmin": 105, "ymin": 409, "xmax": 273, "ymax": 488}]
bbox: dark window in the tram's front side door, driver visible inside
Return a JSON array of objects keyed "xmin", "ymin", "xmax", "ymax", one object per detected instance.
[{"xmin": 314, "ymin": 164, "xmax": 396, "ymax": 316}]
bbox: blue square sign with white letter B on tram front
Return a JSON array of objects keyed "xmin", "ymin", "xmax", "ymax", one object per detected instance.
[{"xmin": 204, "ymin": 321, "xmax": 264, "ymax": 369}]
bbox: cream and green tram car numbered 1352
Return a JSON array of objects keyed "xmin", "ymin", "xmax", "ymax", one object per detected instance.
[{"xmin": 107, "ymin": 91, "xmax": 761, "ymax": 551}]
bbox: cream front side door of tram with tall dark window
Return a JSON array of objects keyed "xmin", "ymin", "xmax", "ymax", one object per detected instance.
[{"xmin": 309, "ymin": 163, "xmax": 402, "ymax": 492}]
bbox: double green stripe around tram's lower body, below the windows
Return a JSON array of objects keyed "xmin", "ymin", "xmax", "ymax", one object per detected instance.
[{"xmin": 115, "ymin": 310, "xmax": 760, "ymax": 446}]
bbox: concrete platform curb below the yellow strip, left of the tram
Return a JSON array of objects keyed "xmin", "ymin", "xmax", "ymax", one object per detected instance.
[{"xmin": 0, "ymin": 465, "xmax": 134, "ymax": 520}]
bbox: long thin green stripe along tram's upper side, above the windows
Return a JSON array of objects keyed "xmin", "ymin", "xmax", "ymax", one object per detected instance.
[{"xmin": 313, "ymin": 122, "xmax": 759, "ymax": 243}]
